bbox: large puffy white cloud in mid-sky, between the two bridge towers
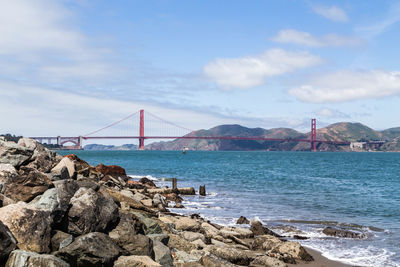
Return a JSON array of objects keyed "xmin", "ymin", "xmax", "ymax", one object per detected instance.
[{"xmin": 204, "ymin": 49, "xmax": 322, "ymax": 89}]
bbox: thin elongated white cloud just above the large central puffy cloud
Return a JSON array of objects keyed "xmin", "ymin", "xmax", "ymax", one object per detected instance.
[{"xmin": 272, "ymin": 29, "xmax": 363, "ymax": 47}]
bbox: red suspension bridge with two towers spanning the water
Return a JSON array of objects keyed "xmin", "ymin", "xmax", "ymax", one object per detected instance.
[{"xmin": 31, "ymin": 110, "xmax": 350, "ymax": 151}]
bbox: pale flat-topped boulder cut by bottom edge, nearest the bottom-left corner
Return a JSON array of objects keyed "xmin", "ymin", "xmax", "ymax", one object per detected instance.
[{"xmin": 6, "ymin": 250, "xmax": 69, "ymax": 267}]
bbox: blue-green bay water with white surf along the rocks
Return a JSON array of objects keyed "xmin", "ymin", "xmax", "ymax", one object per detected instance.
[{"xmin": 62, "ymin": 151, "xmax": 400, "ymax": 266}]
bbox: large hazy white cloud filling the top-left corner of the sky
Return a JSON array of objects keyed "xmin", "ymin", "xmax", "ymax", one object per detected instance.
[{"xmin": 0, "ymin": 0, "xmax": 115, "ymax": 82}]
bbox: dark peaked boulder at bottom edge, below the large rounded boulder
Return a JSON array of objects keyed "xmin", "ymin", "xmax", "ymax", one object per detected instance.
[{"xmin": 54, "ymin": 232, "xmax": 122, "ymax": 267}]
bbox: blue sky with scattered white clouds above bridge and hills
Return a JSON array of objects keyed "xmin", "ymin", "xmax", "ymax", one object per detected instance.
[{"xmin": 0, "ymin": 0, "xmax": 400, "ymax": 144}]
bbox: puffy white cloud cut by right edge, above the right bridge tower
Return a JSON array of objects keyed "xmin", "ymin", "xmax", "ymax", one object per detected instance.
[{"xmin": 289, "ymin": 70, "xmax": 400, "ymax": 103}]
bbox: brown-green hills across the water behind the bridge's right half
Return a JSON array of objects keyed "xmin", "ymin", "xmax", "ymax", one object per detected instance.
[{"xmin": 146, "ymin": 122, "xmax": 400, "ymax": 151}]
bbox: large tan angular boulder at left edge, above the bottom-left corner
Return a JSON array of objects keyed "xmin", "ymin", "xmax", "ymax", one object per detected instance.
[{"xmin": 0, "ymin": 202, "xmax": 52, "ymax": 253}]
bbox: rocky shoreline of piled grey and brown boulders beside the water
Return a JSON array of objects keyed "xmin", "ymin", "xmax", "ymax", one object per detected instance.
[{"xmin": 0, "ymin": 138, "xmax": 348, "ymax": 267}]
